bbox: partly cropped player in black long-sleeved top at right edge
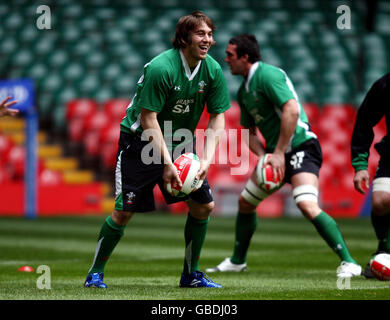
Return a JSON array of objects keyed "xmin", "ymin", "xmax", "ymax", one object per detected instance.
[{"xmin": 351, "ymin": 73, "xmax": 390, "ymax": 278}]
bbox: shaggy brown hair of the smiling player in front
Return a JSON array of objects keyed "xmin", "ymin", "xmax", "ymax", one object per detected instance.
[{"xmin": 172, "ymin": 11, "xmax": 215, "ymax": 49}]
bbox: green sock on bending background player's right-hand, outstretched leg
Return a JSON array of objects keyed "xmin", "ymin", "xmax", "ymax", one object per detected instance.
[{"xmin": 312, "ymin": 211, "xmax": 356, "ymax": 263}]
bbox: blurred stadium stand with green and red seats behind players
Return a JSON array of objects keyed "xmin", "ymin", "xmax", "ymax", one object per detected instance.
[{"xmin": 0, "ymin": 0, "xmax": 390, "ymax": 214}]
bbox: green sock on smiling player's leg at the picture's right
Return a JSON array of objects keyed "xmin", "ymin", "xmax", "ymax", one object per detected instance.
[{"xmin": 183, "ymin": 214, "xmax": 209, "ymax": 274}]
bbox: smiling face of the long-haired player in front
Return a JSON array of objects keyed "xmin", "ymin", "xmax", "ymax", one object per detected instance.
[{"xmin": 183, "ymin": 21, "xmax": 214, "ymax": 68}]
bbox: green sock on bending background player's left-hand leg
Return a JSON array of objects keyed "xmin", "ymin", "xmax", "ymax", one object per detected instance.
[{"xmin": 230, "ymin": 212, "xmax": 257, "ymax": 264}]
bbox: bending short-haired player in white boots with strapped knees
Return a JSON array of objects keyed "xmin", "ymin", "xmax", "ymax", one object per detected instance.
[{"xmin": 206, "ymin": 34, "xmax": 362, "ymax": 277}]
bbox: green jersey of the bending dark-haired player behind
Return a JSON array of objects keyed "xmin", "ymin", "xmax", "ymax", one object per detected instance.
[{"xmin": 237, "ymin": 61, "xmax": 317, "ymax": 152}]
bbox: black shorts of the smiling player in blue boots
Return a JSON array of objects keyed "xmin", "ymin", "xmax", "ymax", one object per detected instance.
[{"xmin": 115, "ymin": 132, "xmax": 213, "ymax": 212}]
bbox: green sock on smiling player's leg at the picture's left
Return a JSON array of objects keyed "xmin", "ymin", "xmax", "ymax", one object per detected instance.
[{"xmin": 88, "ymin": 216, "xmax": 126, "ymax": 273}]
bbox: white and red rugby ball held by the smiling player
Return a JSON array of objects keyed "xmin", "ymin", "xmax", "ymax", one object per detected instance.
[{"xmin": 172, "ymin": 152, "xmax": 203, "ymax": 197}]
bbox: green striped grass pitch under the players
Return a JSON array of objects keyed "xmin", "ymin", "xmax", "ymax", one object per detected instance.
[{"xmin": 0, "ymin": 214, "xmax": 390, "ymax": 300}]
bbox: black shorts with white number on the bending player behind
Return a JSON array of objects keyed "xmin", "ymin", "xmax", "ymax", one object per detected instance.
[{"xmin": 284, "ymin": 139, "xmax": 322, "ymax": 183}]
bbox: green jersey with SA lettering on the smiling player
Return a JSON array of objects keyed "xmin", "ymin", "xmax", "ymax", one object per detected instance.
[{"xmin": 121, "ymin": 49, "xmax": 230, "ymax": 150}]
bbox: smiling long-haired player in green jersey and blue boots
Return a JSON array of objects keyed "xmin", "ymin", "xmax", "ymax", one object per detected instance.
[{"xmin": 84, "ymin": 11, "xmax": 230, "ymax": 288}]
